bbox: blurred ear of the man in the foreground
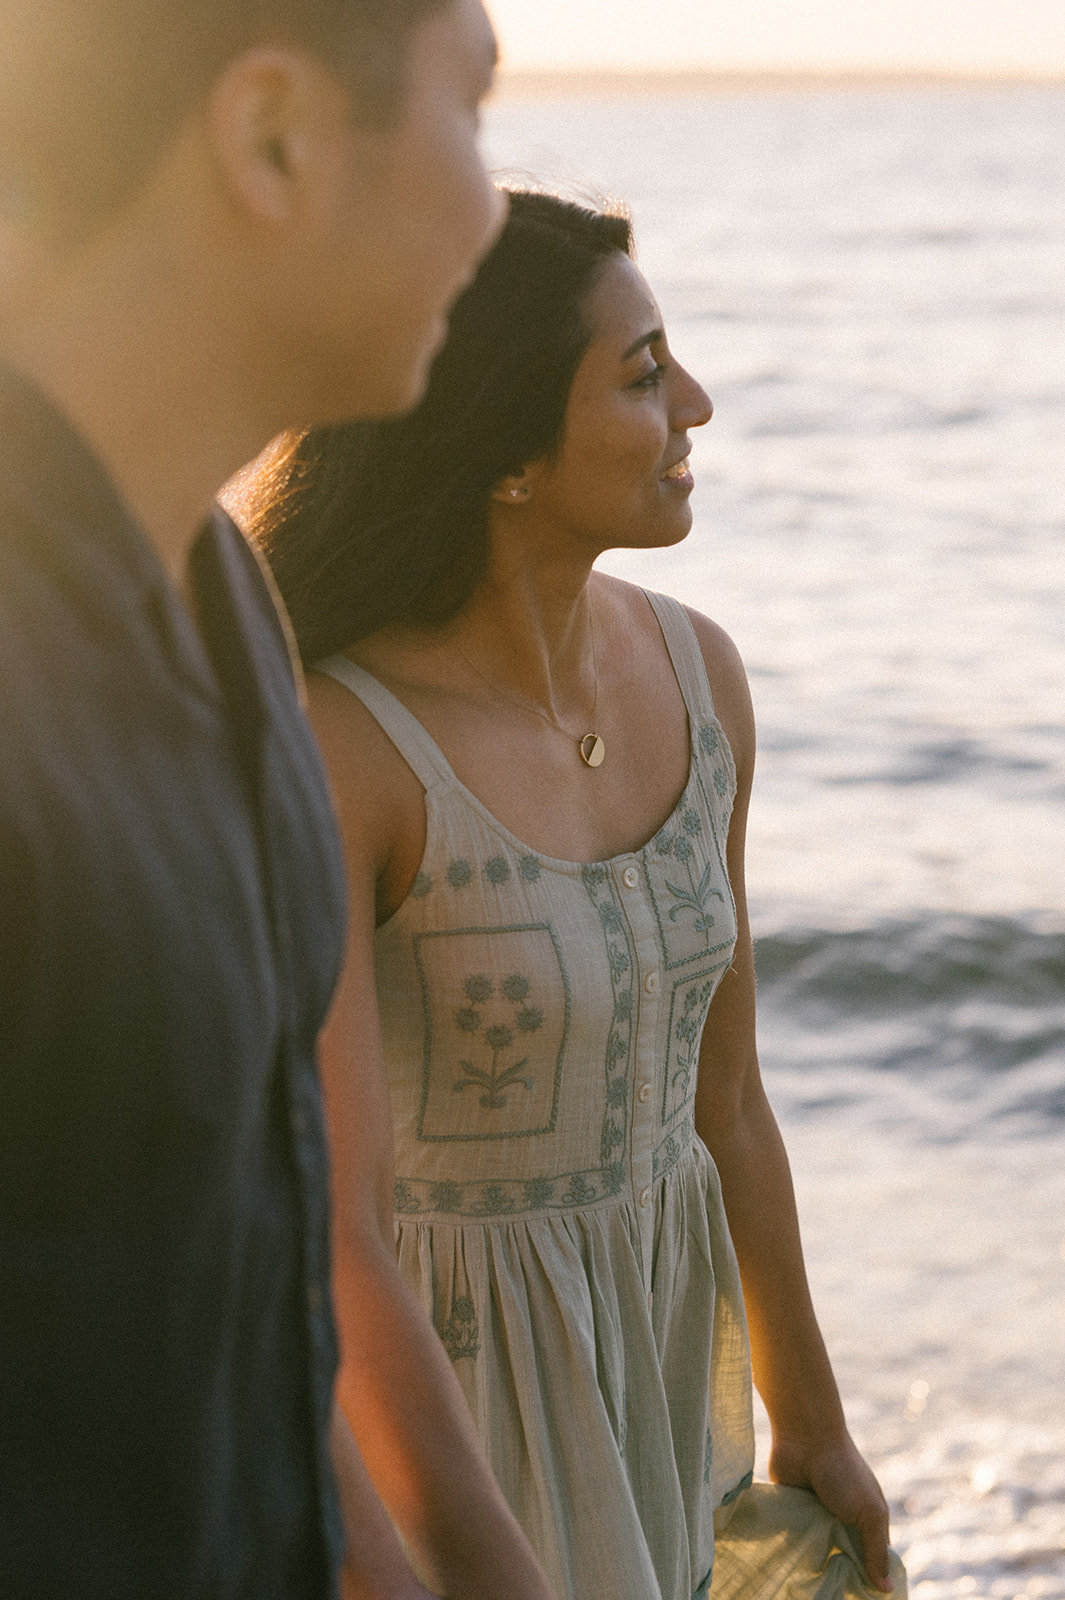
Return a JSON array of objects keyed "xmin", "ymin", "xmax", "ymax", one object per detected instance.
[{"xmin": 206, "ymin": 46, "xmax": 352, "ymax": 224}]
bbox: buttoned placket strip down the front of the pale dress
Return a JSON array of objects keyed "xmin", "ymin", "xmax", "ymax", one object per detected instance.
[{"xmin": 614, "ymin": 861, "xmax": 662, "ymax": 1309}]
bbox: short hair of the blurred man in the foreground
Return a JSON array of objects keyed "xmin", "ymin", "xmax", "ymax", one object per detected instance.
[{"xmin": 0, "ymin": 0, "xmax": 446, "ymax": 240}]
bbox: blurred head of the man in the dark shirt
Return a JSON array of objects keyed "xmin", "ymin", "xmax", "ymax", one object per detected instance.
[{"xmin": 0, "ymin": 0, "xmax": 501, "ymax": 424}]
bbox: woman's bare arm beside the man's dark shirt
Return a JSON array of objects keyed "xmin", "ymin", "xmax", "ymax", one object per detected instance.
[{"xmin": 309, "ymin": 675, "xmax": 552, "ymax": 1600}]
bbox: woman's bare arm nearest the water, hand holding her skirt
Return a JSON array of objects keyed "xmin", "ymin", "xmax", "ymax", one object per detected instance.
[{"xmin": 692, "ymin": 614, "xmax": 891, "ymax": 1592}]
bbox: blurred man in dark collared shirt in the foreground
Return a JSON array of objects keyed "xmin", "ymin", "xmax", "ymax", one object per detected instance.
[{"xmin": 0, "ymin": 0, "xmax": 546, "ymax": 1600}]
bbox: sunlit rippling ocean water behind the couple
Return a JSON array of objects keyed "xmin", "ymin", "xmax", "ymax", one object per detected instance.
[{"xmin": 488, "ymin": 85, "xmax": 1065, "ymax": 1600}]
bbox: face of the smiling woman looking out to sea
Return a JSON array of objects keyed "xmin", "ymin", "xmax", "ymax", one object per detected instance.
[{"xmin": 526, "ymin": 254, "xmax": 713, "ymax": 549}]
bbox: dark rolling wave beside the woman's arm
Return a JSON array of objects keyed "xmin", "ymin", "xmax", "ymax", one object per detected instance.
[{"xmin": 756, "ymin": 915, "xmax": 1065, "ymax": 1139}]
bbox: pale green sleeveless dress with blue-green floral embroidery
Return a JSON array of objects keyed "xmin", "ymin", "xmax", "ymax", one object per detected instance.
[{"xmin": 317, "ymin": 594, "xmax": 901, "ymax": 1600}]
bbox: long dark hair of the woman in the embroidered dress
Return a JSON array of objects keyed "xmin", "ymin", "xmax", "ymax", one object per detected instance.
[{"xmin": 238, "ymin": 190, "xmax": 632, "ymax": 661}]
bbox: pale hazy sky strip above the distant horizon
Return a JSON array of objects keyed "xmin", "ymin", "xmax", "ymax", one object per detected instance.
[{"xmin": 486, "ymin": 0, "xmax": 1065, "ymax": 75}]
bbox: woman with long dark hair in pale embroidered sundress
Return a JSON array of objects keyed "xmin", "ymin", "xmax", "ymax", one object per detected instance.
[{"xmin": 249, "ymin": 194, "xmax": 891, "ymax": 1600}]
